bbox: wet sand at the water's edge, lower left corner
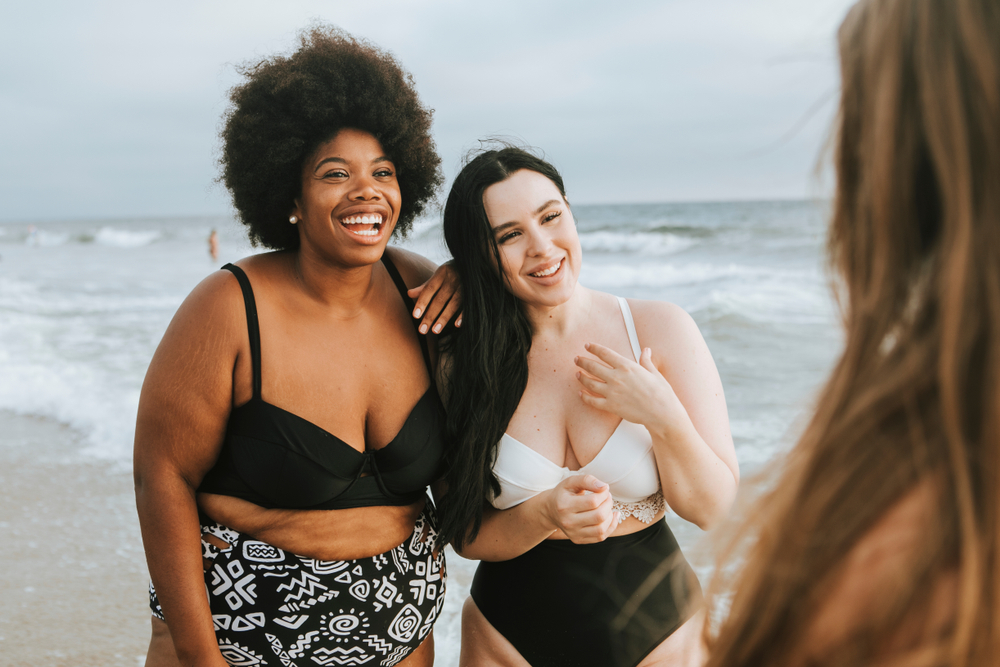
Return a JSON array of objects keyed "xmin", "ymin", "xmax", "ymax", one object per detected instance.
[{"xmin": 0, "ymin": 412, "xmax": 149, "ymax": 667}]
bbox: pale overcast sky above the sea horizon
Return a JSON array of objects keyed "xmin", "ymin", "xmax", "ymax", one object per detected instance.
[{"xmin": 0, "ymin": 0, "xmax": 851, "ymax": 220}]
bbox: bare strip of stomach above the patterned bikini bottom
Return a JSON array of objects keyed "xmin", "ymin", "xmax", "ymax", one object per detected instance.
[{"xmin": 198, "ymin": 493, "xmax": 424, "ymax": 560}]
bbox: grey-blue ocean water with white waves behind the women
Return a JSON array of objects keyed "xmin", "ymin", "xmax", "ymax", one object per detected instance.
[{"xmin": 0, "ymin": 202, "xmax": 841, "ymax": 665}]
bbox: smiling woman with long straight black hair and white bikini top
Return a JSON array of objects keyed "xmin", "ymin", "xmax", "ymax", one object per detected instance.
[{"xmin": 439, "ymin": 147, "xmax": 738, "ymax": 667}]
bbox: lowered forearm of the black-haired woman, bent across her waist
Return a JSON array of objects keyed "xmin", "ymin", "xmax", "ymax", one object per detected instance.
[{"xmin": 460, "ymin": 491, "xmax": 558, "ymax": 561}]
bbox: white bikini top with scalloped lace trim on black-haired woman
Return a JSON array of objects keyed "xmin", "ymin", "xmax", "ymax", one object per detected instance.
[{"xmin": 491, "ymin": 297, "xmax": 666, "ymax": 523}]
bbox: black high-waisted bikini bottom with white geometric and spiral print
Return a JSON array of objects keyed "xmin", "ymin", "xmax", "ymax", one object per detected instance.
[{"xmin": 149, "ymin": 502, "xmax": 445, "ymax": 667}]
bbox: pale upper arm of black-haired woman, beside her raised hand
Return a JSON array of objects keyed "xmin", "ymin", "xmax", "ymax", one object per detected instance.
[{"xmin": 629, "ymin": 299, "xmax": 740, "ymax": 481}]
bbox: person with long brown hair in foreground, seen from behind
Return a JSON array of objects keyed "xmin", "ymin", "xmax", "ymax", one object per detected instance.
[{"xmin": 708, "ymin": 0, "xmax": 1000, "ymax": 667}]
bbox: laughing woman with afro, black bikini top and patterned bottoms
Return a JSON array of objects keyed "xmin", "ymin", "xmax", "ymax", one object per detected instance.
[{"xmin": 134, "ymin": 28, "xmax": 458, "ymax": 667}]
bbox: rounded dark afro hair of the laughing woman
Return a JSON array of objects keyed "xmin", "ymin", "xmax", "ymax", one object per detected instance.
[{"xmin": 219, "ymin": 26, "xmax": 443, "ymax": 250}]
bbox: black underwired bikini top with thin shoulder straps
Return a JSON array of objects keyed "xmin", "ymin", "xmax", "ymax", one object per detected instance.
[{"xmin": 198, "ymin": 257, "xmax": 444, "ymax": 509}]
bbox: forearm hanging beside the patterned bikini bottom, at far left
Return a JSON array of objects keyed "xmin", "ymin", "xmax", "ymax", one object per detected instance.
[{"xmin": 136, "ymin": 475, "xmax": 226, "ymax": 667}]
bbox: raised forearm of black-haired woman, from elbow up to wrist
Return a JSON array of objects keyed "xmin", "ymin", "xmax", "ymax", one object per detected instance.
[{"xmin": 650, "ymin": 419, "xmax": 738, "ymax": 529}]
